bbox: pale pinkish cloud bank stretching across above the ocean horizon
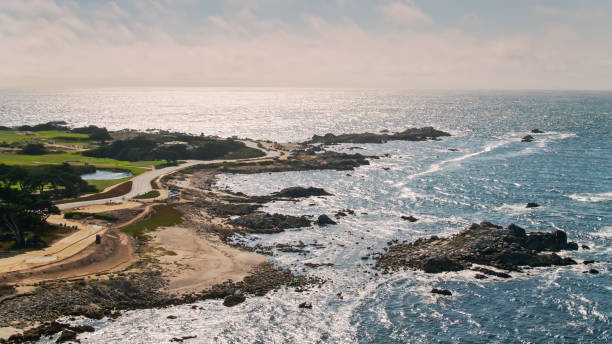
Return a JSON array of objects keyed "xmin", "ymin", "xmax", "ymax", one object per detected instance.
[{"xmin": 0, "ymin": 0, "xmax": 612, "ymax": 89}]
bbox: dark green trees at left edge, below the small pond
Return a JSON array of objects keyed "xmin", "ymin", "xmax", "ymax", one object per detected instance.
[{"xmin": 0, "ymin": 163, "xmax": 91, "ymax": 247}]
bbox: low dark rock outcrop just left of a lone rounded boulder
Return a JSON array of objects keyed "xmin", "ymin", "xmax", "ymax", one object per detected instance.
[{"xmin": 229, "ymin": 211, "xmax": 312, "ymax": 234}]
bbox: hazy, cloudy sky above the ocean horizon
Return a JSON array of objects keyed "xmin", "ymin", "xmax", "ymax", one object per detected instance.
[{"xmin": 0, "ymin": 0, "xmax": 612, "ymax": 90}]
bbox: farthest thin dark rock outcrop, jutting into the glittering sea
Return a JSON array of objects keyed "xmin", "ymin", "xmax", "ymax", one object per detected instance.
[{"xmin": 305, "ymin": 127, "xmax": 451, "ymax": 144}]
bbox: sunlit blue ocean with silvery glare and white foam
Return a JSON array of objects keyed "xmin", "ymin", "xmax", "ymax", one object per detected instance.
[{"xmin": 0, "ymin": 88, "xmax": 612, "ymax": 343}]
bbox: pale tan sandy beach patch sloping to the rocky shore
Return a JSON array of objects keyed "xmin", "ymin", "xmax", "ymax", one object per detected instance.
[{"xmin": 151, "ymin": 226, "xmax": 267, "ymax": 293}]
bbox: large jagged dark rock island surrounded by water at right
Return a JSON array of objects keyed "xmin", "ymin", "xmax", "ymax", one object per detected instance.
[{"xmin": 376, "ymin": 222, "xmax": 578, "ymax": 274}]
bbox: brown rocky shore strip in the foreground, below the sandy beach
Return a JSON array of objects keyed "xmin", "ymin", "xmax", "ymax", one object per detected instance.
[{"xmin": 0, "ymin": 263, "xmax": 316, "ymax": 343}]
